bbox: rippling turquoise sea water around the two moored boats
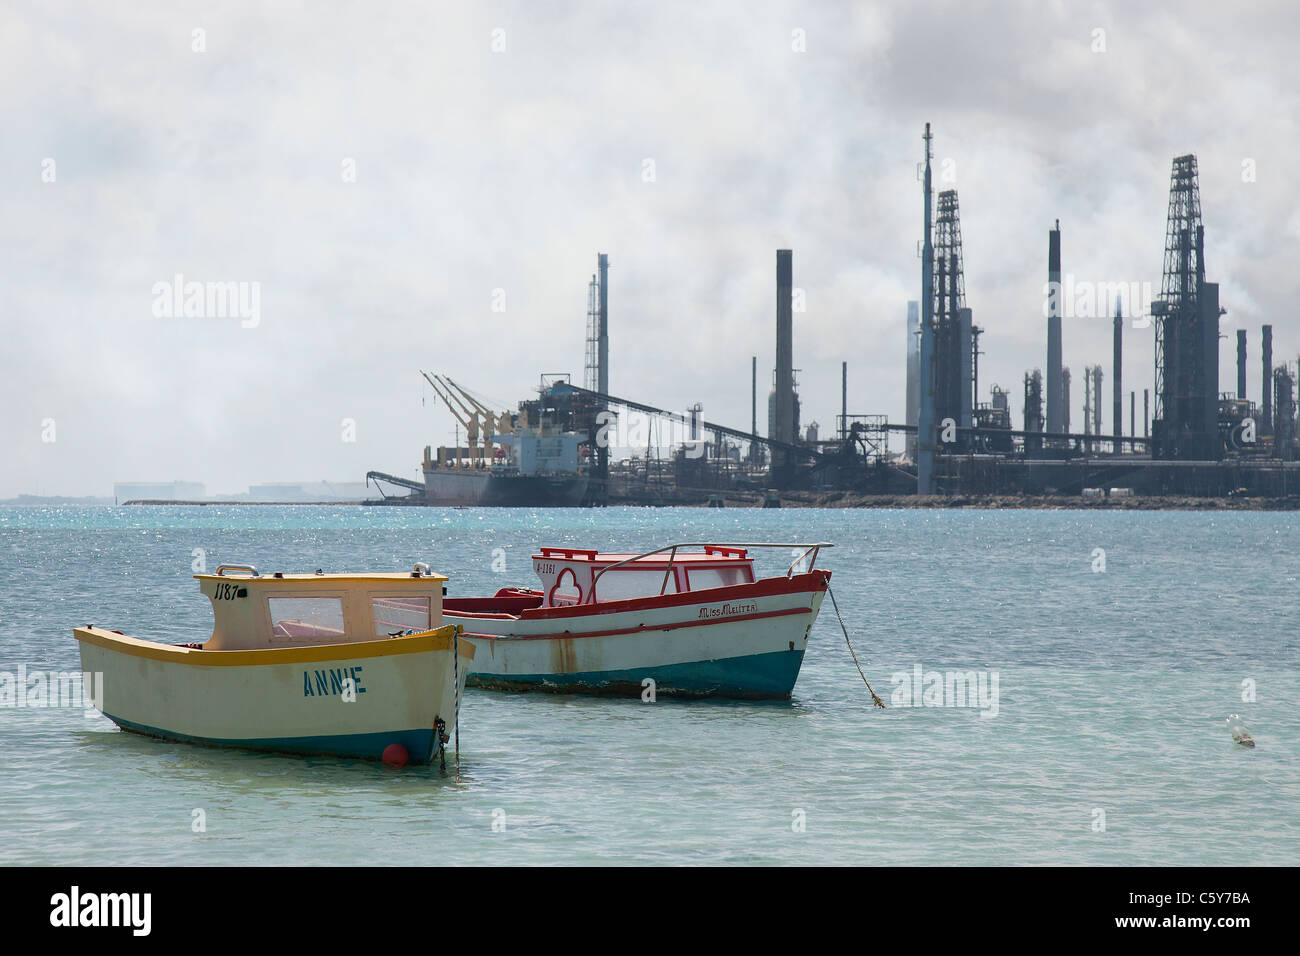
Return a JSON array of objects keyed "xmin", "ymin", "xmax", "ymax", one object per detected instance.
[{"xmin": 0, "ymin": 507, "xmax": 1300, "ymax": 865}]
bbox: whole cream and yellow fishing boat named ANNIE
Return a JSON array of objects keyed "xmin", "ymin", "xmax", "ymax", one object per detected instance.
[{"xmin": 75, "ymin": 563, "xmax": 475, "ymax": 763}]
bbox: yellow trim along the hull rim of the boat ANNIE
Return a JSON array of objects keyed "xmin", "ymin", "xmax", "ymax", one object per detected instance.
[{"xmin": 73, "ymin": 624, "xmax": 475, "ymax": 667}]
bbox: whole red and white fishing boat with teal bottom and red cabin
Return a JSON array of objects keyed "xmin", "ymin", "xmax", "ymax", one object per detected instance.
[{"xmin": 442, "ymin": 544, "xmax": 831, "ymax": 700}]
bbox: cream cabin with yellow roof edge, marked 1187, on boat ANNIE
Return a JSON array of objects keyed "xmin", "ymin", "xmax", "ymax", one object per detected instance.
[{"xmin": 195, "ymin": 563, "xmax": 447, "ymax": 650}]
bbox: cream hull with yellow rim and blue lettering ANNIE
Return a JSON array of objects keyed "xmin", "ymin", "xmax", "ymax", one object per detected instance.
[{"xmin": 75, "ymin": 626, "xmax": 475, "ymax": 763}]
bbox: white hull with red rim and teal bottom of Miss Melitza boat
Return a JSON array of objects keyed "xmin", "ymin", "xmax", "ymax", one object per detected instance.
[{"xmin": 443, "ymin": 571, "xmax": 829, "ymax": 700}]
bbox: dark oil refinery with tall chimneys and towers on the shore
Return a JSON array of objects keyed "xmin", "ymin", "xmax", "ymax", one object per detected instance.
[{"xmin": 367, "ymin": 124, "xmax": 1300, "ymax": 506}]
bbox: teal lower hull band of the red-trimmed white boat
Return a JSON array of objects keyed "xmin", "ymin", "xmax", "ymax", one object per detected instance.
[{"xmin": 467, "ymin": 650, "xmax": 803, "ymax": 700}]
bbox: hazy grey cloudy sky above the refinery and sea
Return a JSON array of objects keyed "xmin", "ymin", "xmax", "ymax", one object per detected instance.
[{"xmin": 0, "ymin": 0, "xmax": 1300, "ymax": 497}]
